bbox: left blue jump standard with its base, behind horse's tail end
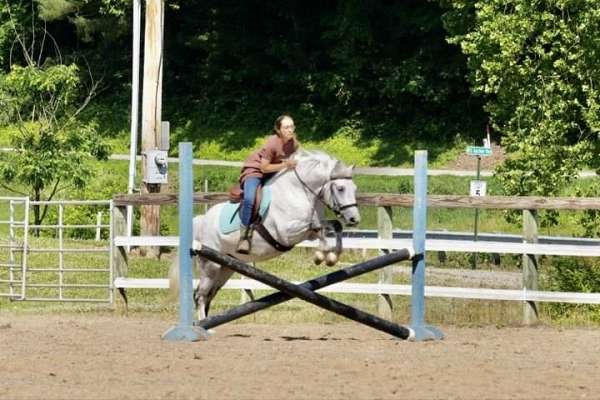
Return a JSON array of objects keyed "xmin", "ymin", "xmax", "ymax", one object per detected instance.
[{"xmin": 162, "ymin": 142, "xmax": 208, "ymax": 342}]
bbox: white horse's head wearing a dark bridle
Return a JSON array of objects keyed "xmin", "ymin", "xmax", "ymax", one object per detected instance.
[{"xmin": 325, "ymin": 161, "xmax": 360, "ymax": 226}]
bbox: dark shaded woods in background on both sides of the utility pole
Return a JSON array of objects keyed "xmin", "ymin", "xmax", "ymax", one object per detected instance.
[{"xmin": 0, "ymin": 0, "xmax": 485, "ymax": 163}]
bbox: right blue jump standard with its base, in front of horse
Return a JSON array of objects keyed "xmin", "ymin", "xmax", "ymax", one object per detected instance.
[{"xmin": 409, "ymin": 150, "xmax": 444, "ymax": 341}]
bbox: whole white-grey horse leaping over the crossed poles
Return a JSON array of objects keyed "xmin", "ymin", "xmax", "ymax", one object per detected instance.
[{"xmin": 171, "ymin": 150, "xmax": 360, "ymax": 320}]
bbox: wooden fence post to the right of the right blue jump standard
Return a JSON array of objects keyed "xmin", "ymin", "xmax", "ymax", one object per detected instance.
[{"xmin": 523, "ymin": 210, "xmax": 539, "ymax": 325}]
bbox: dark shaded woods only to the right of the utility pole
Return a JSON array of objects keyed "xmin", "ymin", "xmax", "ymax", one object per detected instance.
[{"xmin": 164, "ymin": 0, "xmax": 484, "ymax": 151}]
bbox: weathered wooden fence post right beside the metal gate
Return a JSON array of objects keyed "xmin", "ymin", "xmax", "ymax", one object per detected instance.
[{"xmin": 110, "ymin": 206, "xmax": 129, "ymax": 313}]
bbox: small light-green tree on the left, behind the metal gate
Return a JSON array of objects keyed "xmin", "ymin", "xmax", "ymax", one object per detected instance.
[{"xmin": 0, "ymin": 3, "xmax": 108, "ymax": 231}]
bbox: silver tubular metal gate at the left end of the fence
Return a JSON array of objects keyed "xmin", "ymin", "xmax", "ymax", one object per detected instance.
[{"xmin": 0, "ymin": 198, "xmax": 113, "ymax": 302}]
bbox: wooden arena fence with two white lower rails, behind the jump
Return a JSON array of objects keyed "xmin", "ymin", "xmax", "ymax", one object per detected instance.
[{"xmin": 114, "ymin": 188, "xmax": 600, "ymax": 323}]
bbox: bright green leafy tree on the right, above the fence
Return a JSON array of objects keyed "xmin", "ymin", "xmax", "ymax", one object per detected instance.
[{"xmin": 442, "ymin": 0, "xmax": 600, "ymax": 200}]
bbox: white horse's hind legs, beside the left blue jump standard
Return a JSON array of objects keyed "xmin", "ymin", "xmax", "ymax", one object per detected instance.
[{"xmin": 194, "ymin": 257, "xmax": 233, "ymax": 320}]
